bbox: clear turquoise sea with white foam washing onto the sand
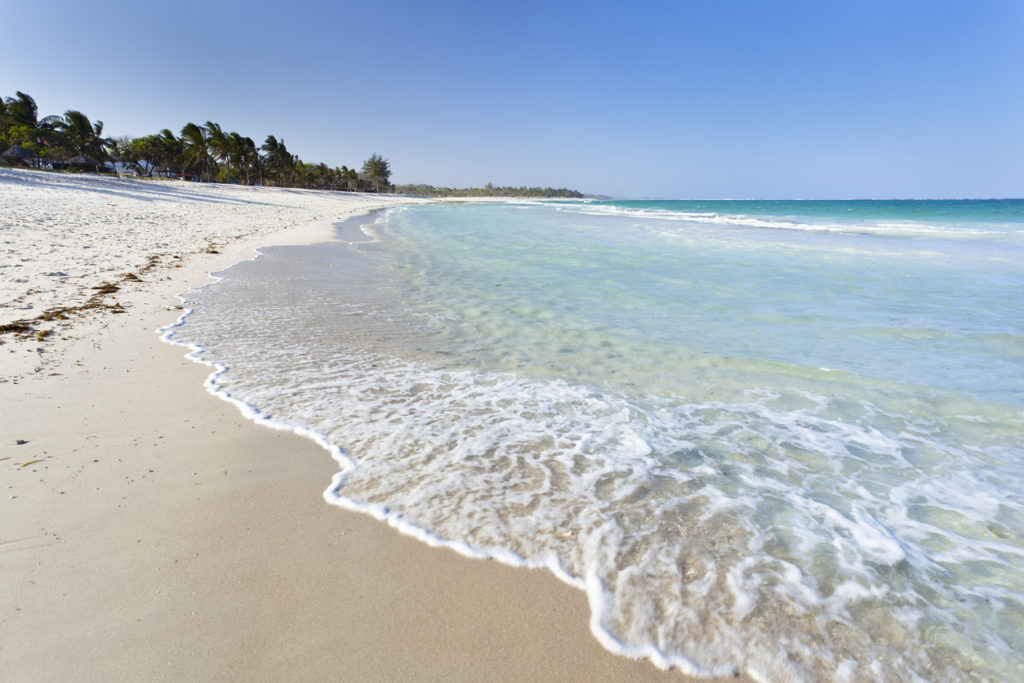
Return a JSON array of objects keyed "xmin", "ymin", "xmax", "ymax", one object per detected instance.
[{"xmin": 168, "ymin": 200, "xmax": 1024, "ymax": 680}]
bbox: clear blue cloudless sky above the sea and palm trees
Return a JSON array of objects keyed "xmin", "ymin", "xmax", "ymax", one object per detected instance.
[{"xmin": 0, "ymin": 0, "xmax": 1024, "ymax": 199}]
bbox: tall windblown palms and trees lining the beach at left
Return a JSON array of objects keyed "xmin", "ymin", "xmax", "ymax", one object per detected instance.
[{"xmin": 0, "ymin": 91, "xmax": 392, "ymax": 193}]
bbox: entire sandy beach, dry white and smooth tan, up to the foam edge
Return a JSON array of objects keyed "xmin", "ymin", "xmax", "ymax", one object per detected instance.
[{"xmin": 0, "ymin": 169, "xmax": 737, "ymax": 681}]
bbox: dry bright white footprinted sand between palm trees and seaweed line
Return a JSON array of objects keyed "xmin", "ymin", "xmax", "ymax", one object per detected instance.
[{"xmin": 0, "ymin": 168, "xmax": 420, "ymax": 377}]
